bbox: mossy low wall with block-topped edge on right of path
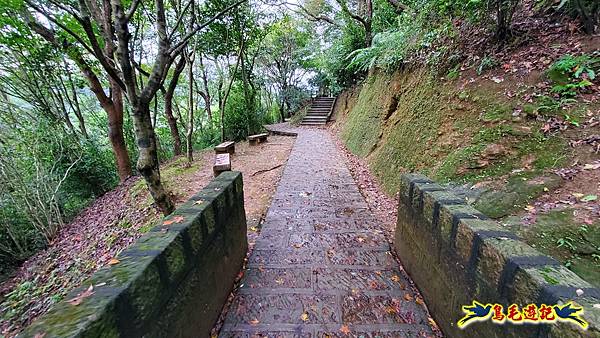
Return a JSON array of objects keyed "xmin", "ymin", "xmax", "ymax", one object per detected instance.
[{"xmin": 394, "ymin": 174, "xmax": 600, "ymax": 338}]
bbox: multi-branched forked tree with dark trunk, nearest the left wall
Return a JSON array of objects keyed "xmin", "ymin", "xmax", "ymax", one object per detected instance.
[{"xmin": 25, "ymin": 0, "xmax": 246, "ymax": 214}]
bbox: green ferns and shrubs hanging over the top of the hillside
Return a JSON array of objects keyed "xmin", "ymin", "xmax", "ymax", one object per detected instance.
[{"xmin": 325, "ymin": 0, "xmax": 492, "ymax": 83}]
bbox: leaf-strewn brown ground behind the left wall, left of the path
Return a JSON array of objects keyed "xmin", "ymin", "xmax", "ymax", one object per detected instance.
[{"xmin": 0, "ymin": 136, "xmax": 294, "ymax": 338}]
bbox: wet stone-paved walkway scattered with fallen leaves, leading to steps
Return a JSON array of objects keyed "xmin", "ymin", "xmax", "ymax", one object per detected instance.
[{"xmin": 219, "ymin": 129, "xmax": 433, "ymax": 338}]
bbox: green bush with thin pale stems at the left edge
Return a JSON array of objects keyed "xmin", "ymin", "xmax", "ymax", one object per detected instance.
[{"xmin": 0, "ymin": 120, "xmax": 117, "ymax": 266}]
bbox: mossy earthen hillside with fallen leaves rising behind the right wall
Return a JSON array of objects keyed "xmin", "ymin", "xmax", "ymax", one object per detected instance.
[{"xmin": 334, "ymin": 37, "xmax": 600, "ymax": 285}]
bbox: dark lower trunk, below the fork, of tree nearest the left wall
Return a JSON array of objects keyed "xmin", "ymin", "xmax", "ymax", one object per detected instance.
[{"xmin": 133, "ymin": 101, "xmax": 175, "ymax": 215}]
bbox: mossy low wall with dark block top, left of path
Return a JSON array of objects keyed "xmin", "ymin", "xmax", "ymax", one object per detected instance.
[{"xmin": 21, "ymin": 172, "xmax": 248, "ymax": 338}]
